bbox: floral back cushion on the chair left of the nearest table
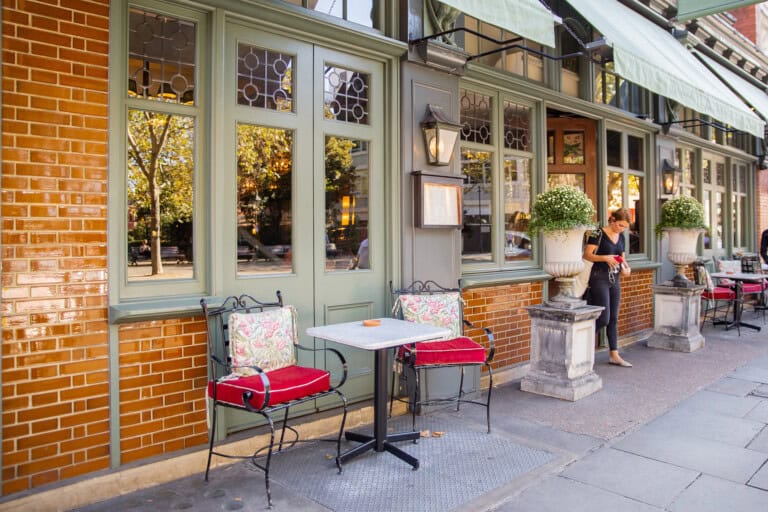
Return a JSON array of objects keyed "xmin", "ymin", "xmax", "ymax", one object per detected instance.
[{"xmin": 229, "ymin": 306, "xmax": 297, "ymax": 375}]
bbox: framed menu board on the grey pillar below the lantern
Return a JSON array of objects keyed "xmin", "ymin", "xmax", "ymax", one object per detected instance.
[{"xmin": 413, "ymin": 171, "xmax": 464, "ymax": 228}]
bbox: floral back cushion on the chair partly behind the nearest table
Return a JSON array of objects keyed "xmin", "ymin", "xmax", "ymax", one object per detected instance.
[{"xmin": 399, "ymin": 292, "xmax": 462, "ymax": 338}]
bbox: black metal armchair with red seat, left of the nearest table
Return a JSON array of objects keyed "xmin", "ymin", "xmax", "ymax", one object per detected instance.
[{"xmin": 200, "ymin": 291, "xmax": 347, "ymax": 508}]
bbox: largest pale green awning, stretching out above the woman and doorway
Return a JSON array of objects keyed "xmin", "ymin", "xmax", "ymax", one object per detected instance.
[{"xmin": 567, "ymin": 0, "xmax": 765, "ymax": 138}]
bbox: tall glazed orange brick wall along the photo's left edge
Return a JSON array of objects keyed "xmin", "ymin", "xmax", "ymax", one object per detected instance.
[{"xmin": 2, "ymin": 0, "xmax": 109, "ymax": 495}]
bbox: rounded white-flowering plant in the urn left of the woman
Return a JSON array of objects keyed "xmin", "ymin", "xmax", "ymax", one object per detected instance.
[{"xmin": 528, "ymin": 185, "xmax": 595, "ymax": 236}]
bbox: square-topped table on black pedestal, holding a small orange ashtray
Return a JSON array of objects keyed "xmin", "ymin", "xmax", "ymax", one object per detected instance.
[{"xmin": 307, "ymin": 318, "xmax": 450, "ymax": 469}]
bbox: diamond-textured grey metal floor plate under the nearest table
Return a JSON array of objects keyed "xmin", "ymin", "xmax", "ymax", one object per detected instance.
[{"xmin": 270, "ymin": 415, "xmax": 555, "ymax": 512}]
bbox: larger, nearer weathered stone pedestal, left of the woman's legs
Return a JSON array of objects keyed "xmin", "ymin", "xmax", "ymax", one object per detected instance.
[{"xmin": 520, "ymin": 305, "xmax": 603, "ymax": 401}]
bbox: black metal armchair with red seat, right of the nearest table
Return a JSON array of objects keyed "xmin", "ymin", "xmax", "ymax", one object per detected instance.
[{"xmin": 389, "ymin": 281, "xmax": 495, "ymax": 433}]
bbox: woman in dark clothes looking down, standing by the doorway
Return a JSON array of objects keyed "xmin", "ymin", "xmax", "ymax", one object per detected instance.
[{"xmin": 584, "ymin": 208, "xmax": 632, "ymax": 368}]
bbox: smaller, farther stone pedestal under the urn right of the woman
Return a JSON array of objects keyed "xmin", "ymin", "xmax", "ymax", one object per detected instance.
[{"xmin": 646, "ymin": 284, "xmax": 704, "ymax": 352}]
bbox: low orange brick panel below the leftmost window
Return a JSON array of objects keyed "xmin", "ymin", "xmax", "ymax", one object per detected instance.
[{"xmin": 120, "ymin": 317, "xmax": 208, "ymax": 463}]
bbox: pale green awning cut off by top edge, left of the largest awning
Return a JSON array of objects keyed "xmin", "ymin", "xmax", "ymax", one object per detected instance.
[{"xmin": 440, "ymin": 0, "xmax": 555, "ymax": 48}]
